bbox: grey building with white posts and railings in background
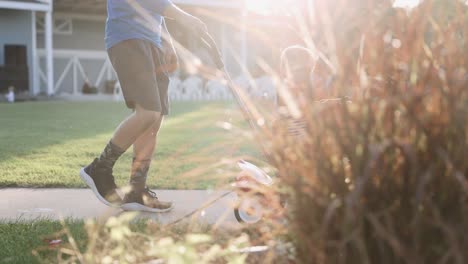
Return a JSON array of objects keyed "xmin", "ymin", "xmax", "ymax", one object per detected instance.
[{"xmin": 0, "ymin": 0, "xmax": 252, "ymax": 95}]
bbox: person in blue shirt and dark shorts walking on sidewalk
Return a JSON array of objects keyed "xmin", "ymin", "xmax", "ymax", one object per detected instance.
[{"xmin": 80, "ymin": 0, "xmax": 207, "ymax": 212}]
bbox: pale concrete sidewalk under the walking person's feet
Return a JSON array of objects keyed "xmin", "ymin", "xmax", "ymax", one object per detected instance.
[{"xmin": 0, "ymin": 188, "xmax": 239, "ymax": 228}]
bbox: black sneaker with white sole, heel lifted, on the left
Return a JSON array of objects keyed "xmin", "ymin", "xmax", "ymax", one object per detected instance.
[{"xmin": 80, "ymin": 159, "xmax": 122, "ymax": 207}]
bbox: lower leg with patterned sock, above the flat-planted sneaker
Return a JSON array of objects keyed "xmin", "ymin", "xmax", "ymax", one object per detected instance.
[{"xmin": 130, "ymin": 117, "xmax": 163, "ymax": 190}]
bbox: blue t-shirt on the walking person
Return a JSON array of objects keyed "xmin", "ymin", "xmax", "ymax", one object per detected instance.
[{"xmin": 105, "ymin": 0, "xmax": 171, "ymax": 49}]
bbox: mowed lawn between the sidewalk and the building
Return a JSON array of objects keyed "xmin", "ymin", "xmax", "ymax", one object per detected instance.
[{"xmin": 0, "ymin": 102, "xmax": 259, "ymax": 189}]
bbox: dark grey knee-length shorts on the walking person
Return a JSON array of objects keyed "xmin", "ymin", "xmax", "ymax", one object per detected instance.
[{"xmin": 107, "ymin": 39, "xmax": 169, "ymax": 115}]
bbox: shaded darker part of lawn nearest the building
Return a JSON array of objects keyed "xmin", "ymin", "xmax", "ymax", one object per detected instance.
[{"xmin": 0, "ymin": 102, "xmax": 214, "ymax": 162}]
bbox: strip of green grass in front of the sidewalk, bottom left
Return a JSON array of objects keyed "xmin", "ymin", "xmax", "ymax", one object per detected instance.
[{"xmin": 0, "ymin": 219, "xmax": 209, "ymax": 264}]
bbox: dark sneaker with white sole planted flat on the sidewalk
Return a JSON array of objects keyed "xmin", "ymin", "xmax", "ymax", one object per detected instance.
[{"xmin": 121, "ymin": 187, "xmax": 173, "ymax": 213}]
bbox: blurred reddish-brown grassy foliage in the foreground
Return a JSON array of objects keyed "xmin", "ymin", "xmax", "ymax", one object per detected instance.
[{"xmin": 38, "ymin": 0, "xmax": 468, "ymax": 264}]
